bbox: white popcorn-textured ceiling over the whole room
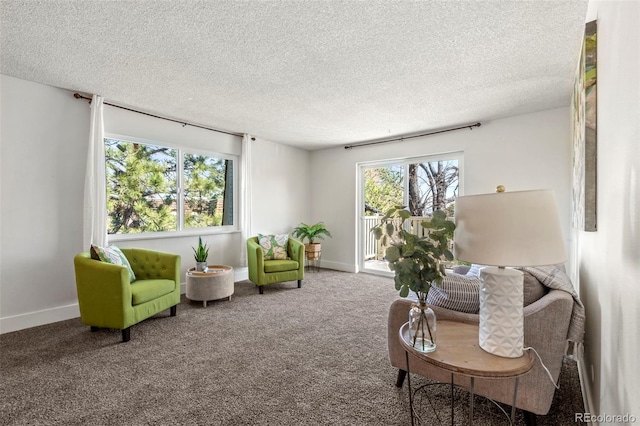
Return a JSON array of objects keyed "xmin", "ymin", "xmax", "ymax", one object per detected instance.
[{"xmin": 0, "ymin": 0, "xmax": 587, "ymax": 150}]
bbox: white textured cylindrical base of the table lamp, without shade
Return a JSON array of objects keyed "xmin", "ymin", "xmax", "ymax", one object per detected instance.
[{"xmin": 479, "ymin": 266, "xmax": 524, "ymax": 358}]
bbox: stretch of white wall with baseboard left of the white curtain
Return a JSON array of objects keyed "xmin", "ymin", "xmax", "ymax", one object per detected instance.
[{"xmin": 0, "ymin": 76, "xmax": 89, "ymax": 331}]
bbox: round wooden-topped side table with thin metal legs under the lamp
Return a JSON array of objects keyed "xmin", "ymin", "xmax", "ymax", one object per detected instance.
[{"xmin": 400, "ymin": 320, "xmax": 535, "ymax": 425}]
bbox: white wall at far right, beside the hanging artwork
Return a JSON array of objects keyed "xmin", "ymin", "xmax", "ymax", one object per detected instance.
[{"xmin": 575, "ymin": 1, "xmax": 640, "ymax": 422}]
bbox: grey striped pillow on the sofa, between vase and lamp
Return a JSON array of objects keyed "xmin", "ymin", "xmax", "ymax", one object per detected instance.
[{"xmin": 427, "ymin": 273, "xmax": 480, "ymax": 314}]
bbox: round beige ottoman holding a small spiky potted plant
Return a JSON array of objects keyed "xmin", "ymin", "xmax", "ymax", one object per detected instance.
[{"xmin": 187, "ymin": 265, "xmax": 235, "ymax": 308}]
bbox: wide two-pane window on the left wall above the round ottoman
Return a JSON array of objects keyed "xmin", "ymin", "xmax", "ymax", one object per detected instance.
[{"xmin": 105, "ymin": 137, "xmax": 236, "ymax": 235}]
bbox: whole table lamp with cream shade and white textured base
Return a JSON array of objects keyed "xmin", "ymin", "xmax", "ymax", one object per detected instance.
[{"xmin": 453, "ymin": 186, "xmax": 567, "ymax": 358}]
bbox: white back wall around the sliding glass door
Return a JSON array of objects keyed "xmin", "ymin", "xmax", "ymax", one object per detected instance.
[{"xmin": 311, "ymin": 108, "xmax": 571, "ymax": 272}]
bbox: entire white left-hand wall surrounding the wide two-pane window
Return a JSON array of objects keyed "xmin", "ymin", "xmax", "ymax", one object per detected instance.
[{"xmin": 0, "ymin": 75, "xmax": 310, "ymax": 333}]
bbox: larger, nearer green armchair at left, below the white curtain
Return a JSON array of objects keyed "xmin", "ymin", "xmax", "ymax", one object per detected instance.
[{"xmin": 74, "ymin": 248, "xmax": 180, "ymax": 342}]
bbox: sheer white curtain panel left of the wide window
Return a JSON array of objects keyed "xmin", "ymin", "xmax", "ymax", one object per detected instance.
[{"xmin": 82, "ymin": 95, "xmax": 107, "ymax": 250}]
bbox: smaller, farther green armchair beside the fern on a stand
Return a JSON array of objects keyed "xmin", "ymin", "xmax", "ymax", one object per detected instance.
[{"xmin": 247, "ymin": 237, "xmax": 304, "ymax": 294}]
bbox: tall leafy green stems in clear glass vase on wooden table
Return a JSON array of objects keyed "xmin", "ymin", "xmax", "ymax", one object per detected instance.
[{"xmin": 371, "ymin": 206, "xmax": 455, "ymax": 352}]
